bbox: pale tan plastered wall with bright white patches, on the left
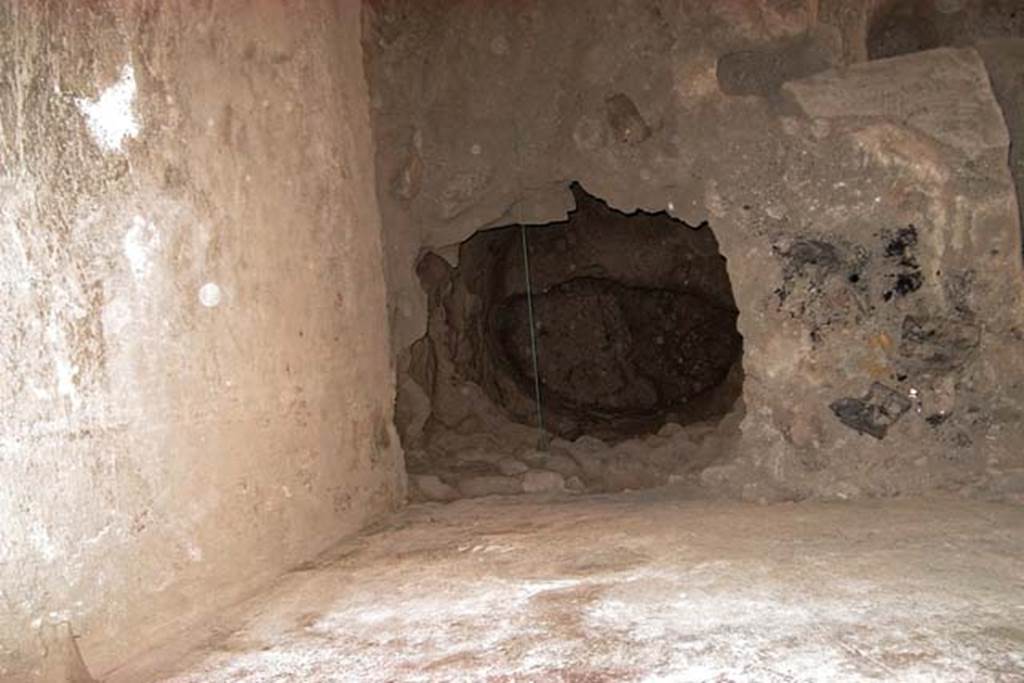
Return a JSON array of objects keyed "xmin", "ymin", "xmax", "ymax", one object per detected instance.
[{"xmin": 0, "ymin": 0, "xmax": 404, "ymax": 680}]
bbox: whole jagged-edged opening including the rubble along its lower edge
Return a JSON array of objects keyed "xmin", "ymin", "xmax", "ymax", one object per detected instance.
[{"xmin": 399, "ymin": 183, "xmax": 743, "ymax": 493}]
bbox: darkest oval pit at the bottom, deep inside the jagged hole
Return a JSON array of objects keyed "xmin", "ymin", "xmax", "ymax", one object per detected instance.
[{"xmin": 497, "ymin": 278, "xmax": 740, "ymax": 430}]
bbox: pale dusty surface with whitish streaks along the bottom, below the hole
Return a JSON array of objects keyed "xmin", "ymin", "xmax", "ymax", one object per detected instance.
[{"xmin": 109, "ymin": 489, "xmax": 1024, "ymax": 683}]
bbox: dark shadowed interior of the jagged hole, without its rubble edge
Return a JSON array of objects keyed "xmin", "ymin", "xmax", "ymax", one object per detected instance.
[{"xmin": 432, "ymin": 184, "xmax": 742, "ymax": 440}]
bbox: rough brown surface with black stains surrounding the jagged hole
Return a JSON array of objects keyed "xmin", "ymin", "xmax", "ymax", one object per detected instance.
[{"xmin": 365, "ymin": 0, "xmax": 1024, "ymax": 498}]
